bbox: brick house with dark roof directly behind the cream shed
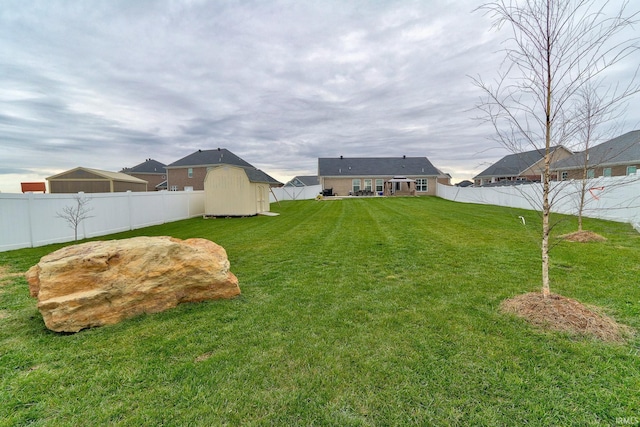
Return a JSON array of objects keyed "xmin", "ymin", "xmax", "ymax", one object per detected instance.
[{"xmin": 166, "ymin": 148, "xmax": 282, "ymax": 191}]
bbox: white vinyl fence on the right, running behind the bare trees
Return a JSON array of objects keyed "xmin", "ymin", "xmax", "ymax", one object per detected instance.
[{"xmin": 437, "ymin": 175, "xmax": 640, "ymax": 231}]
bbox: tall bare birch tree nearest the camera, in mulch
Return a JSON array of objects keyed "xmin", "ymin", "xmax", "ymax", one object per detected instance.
[{"xmin": 473, "ymin": 0, "xmax": 638, "ymax": 297}]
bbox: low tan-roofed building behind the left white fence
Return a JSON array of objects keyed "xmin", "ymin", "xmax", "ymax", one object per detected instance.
[{"xmin": 47, "ymin": 167, "xmax": 147, "ymax": 193}]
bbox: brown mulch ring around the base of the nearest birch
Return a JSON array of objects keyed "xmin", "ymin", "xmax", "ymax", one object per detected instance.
[{"xmin": 500, "ymin": 292, "xmax": 633, "ymax": 343}]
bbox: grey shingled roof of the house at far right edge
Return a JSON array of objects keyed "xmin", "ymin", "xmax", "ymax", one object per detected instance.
[{"xmin": 551, "ymin": 130, "xmax": 640, "ymax": 170}]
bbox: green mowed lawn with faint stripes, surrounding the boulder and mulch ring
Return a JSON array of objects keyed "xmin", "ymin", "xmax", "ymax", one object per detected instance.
[{"xmin": 0, "ymin": 198, "xmax": 640, "ymax": 426}]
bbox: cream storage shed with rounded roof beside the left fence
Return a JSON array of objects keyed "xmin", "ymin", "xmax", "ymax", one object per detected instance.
[{"xmin": 204, "ymin": 165, "xmax": 273, "ymax": 217}]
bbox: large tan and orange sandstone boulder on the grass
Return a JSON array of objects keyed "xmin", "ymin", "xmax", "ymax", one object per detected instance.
[{"xmin": 26, "ymin": 236, "xmax": 240, "ymax": 332}]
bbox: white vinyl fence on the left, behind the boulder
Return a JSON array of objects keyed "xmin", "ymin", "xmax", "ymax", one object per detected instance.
[{"xmin": 0, "ymin": 191, "xmax": 204, "ymax": 252}]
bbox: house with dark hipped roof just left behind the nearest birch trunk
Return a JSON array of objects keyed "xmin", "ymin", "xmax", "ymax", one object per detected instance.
[{"xmin": 473, "ymin": 145, "xmax": 573, "ymax": 186}]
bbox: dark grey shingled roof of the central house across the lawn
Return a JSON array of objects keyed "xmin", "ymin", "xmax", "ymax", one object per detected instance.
[{"xmin": 318, "ymin": 157, "xmax": 443, "ymax": 176}]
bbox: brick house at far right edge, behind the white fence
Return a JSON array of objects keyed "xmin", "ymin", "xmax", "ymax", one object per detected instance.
[{"xmin": 551, "ymin": 130, "xmax": 640, "ymax": 180}]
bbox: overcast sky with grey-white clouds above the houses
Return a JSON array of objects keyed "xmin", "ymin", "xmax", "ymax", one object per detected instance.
[{"xmin": 0, "ymin": 0, "xmax": 640, "ymax": 192}]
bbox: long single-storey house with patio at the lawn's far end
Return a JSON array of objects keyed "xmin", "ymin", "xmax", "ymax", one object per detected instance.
[{"xmin": 318, "ymin": 156, "xmax": 451, "ymax": 196}]
